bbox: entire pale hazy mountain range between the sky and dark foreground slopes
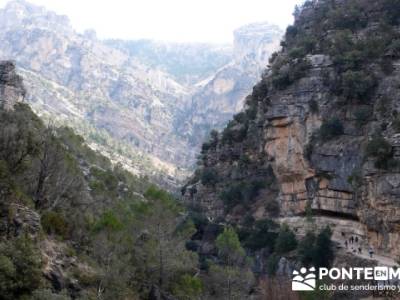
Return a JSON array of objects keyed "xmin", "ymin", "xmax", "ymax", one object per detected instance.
[{"xmin": 0, "ymin": 0, "xmax": 280, "ymax": 185}]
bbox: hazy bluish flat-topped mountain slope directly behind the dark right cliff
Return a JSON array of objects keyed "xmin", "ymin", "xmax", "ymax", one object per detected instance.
[{"xmin": 179, "ymin": 23, "xmax": 283, "ymax": 149}]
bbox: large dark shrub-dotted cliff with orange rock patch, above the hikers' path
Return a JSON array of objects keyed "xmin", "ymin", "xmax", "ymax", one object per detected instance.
[{"xmin": 183, "ymin": 0, "xmax": 400, "ymax": 259}]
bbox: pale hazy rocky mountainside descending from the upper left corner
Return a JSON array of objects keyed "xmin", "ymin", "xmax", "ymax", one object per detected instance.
[{"xmin": 0, "ymin": 1, "xmax": 190, "ymax": 184}]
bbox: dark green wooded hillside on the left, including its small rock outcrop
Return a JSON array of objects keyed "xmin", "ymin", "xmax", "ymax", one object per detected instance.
[{"xmin": 0, "ymin": 61, "xmax": 198, "ymax": 300}]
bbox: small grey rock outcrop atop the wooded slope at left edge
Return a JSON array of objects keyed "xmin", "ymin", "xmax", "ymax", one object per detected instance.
[{"xmin": 0, "ymin": 61, "xmax": 25, "ymax": 110}]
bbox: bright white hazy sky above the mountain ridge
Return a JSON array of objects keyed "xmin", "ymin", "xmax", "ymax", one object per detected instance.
[{"xmin": 0, "ymin": 0, "xmax": 303, "ymax": 43}]
